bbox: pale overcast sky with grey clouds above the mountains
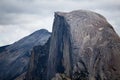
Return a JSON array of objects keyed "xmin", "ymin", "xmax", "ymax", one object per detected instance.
[{"xmin": 0, "ymin": 0, "xmax": 120, "ymax": 46}]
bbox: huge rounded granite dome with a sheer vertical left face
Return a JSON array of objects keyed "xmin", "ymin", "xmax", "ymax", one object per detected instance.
[{"xmin": 47, "ymin": 10, "xmax": 120, "ymax": 80}]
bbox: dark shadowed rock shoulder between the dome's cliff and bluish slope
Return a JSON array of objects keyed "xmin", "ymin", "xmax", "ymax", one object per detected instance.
[{"xmin": 26, "ymin": 40, "xmax": 50, "ymax": 80}]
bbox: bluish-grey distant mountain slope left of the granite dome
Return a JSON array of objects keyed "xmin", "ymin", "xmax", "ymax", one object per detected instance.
[{"xmin": 0, "ymin": 29, "xmax": 51, "ymax": 80}]
